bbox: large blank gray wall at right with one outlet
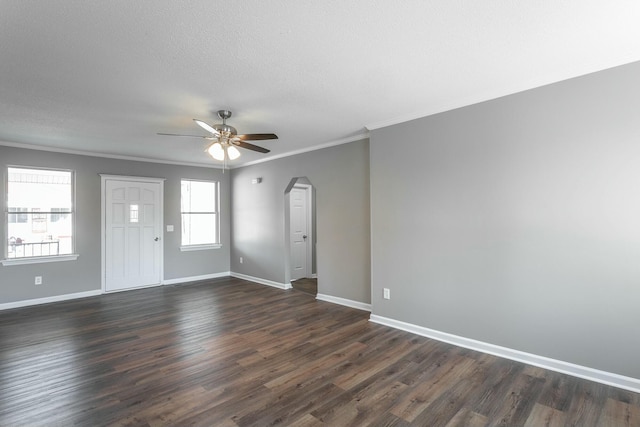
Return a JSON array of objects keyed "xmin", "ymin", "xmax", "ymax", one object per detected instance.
[{"xmin": 370, "ymin": 63, "xmax": 640, "ymax": 378}]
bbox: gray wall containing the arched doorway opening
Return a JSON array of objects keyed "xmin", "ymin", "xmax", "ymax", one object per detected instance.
[{"xmin": 231, "ymin": 140, "xmax": 371, "ymax": 303}]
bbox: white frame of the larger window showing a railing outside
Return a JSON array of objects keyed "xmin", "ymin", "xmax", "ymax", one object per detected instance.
[{"xmin": 0, "ymin": 164, "xmax": 79, "ymax": 266}]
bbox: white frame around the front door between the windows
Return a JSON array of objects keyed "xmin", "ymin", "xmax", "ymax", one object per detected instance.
[{"xmin": 99, "ymin": 173, "xmax": 165, "ymax": 294}]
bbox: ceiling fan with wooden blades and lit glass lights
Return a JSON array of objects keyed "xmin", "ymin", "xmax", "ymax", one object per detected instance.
[{"xmin": 158, "ymin": 110, "xmax": 278, "ymax": 163}]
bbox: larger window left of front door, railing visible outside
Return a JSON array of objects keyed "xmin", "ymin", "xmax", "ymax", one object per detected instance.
[{"xmin": 2, "ymin": 167, "xmax": 77, "ymax": 265}]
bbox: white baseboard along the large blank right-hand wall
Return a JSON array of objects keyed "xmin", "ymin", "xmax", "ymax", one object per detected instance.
[{"xmin": 369, "ymin": 314, "xmax": 640, "ymax": 393}]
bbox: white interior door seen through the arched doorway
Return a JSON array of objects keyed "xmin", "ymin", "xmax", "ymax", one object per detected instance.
[{"xmin": 289, "ymin": 187, "xmax": 310, "ymax": 280}]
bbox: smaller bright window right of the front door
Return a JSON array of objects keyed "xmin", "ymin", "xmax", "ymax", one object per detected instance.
[{"xmin": 181, "ymin": 180, "xmax": 220, "ymax": 250}]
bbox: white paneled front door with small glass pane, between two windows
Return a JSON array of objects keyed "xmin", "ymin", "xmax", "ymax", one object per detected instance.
[{"xmin": 105, "ymin": 180, "xmax": 162, "ymax": 292}]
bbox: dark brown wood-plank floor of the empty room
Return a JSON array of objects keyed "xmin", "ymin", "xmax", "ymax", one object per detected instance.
[{"xmin": 0, "ymin": 278, "xmax": 640, "ymax": 427}]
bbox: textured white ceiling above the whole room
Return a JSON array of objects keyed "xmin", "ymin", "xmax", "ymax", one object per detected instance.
[{"xmin": 0, "ymin": 0, "xmax": 640, "ymax": 166}]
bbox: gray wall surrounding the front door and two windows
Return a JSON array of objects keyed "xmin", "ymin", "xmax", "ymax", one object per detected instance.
[{"xmin": 0, "ymin": 146, "xmax": 230, "ymax": 304}]
